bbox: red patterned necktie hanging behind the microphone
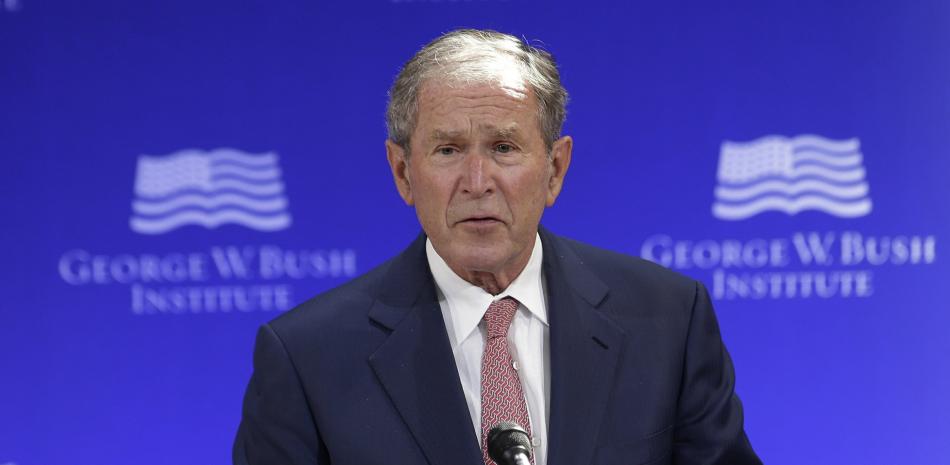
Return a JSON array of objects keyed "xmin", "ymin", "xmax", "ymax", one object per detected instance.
[{"xmin": 482, "ymin": 297, "xmax": 534, "ymax": 465}]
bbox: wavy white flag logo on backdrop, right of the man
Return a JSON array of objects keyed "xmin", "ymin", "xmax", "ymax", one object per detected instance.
[{"xmin": 712, "ymin": 135, "xmax": 872, "ymax": 220}]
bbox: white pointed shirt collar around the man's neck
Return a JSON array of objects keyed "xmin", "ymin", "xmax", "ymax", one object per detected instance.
[{"xmin": 426, "ymin": 234, "xmax": 548, "ymax": 345}]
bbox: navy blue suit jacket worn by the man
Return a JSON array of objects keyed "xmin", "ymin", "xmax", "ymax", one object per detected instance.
[{"xmin": 233, "ymin": 228, "xmax": 760, "ymax": 465}]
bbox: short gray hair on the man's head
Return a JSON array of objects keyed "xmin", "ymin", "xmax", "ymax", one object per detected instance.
[{"xmin": 386, "ymin": 29, "xmax": 567, "ymax": 154}]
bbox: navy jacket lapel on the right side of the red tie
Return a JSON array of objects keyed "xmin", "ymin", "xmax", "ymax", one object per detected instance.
[{"xmin": 540, "ymin": 229, "xmax": 625, "ymax": 465}]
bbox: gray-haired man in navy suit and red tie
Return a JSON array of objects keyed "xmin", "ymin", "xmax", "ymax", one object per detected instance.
[{"xmin": 233, "ymin": 30, "xmax": 760, "ymax": 465}]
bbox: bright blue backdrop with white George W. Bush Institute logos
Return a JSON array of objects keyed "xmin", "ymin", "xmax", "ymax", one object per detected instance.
[{"xmin": 0, "ymin": 0, "xmax": 950, "ymax": 465}]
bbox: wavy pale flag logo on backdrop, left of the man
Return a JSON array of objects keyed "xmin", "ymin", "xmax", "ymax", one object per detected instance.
[{"xmin": 129, "ymin": 149, "xmax": 291, "ymax": 234}]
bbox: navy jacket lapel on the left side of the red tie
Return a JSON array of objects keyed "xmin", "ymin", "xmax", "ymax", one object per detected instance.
[{"xmin": 369, "ymin": 235, "xmax": 482, "ymax": 465}]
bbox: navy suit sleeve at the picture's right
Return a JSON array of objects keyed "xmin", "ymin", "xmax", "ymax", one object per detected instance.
[{"xmin": 673, "ymin": 283, "xmax": 762, "ymax": 465}]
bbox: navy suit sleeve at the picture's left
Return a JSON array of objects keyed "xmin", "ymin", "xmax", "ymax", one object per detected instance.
[{"xmin": 232, "ymin": 325, "xmax": 330, "ymax": 465}]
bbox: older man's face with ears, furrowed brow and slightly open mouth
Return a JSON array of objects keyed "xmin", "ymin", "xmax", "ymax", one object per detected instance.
[{"xmin": 387, "ymin": 83, "xmax": 572, "ymax": 289}]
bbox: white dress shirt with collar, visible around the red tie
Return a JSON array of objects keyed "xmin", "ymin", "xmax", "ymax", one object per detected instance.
[{"xmin": 426, "ymin": 235, "xmax": 551, "ymax": 465}]
